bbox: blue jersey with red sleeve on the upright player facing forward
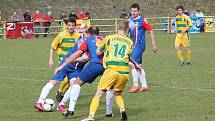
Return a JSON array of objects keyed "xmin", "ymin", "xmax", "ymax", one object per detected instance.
[{"xmin": 129, "ymin": 16, "xmax": 152, "ymax": 48}]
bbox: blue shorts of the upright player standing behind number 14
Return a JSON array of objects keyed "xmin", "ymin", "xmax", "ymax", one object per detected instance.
[{"xmin": 131, "ymin": 46, "xmax": 145, "ymax": 64}]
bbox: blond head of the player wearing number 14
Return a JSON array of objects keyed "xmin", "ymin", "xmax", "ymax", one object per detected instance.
[{"xmin": 118, "ymin": 20, "xmax": 129, "ymax": 35}]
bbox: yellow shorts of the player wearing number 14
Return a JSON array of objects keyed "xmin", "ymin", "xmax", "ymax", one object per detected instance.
[{"xmin": 97, "ymin": 68, "xmax": 129, "ymax": 91}]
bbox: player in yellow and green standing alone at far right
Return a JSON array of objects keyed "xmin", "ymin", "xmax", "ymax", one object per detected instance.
[{"xmin": 175, "ymin": 5, "xmax": 192, "ymax": 66}]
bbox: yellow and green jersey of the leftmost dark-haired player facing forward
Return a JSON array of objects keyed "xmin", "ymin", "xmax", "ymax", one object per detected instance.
[{"xmin": 51, "ymin": 30, "xmax": 80, "ymax": 60}]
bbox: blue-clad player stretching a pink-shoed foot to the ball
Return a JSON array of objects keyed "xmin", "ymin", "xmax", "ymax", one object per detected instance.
[{"xmin": 34, "ymin": 31, "xmax": 89, "ymax": 111}]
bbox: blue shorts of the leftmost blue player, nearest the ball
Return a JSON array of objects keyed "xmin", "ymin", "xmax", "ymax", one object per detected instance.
[{"xmin": 51, "ymin": 69, "xmax": 82, "ymax": 82}]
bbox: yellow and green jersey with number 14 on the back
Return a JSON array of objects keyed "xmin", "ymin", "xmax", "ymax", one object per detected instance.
[{"xmin": 96, "ymin": 34, "xmax": 133, "ymax": 74}]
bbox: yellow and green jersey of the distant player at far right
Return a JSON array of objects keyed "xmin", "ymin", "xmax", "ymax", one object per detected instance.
[{"xmin": 176, "ymin": 14, "xmax": 192, "ymax": 33}]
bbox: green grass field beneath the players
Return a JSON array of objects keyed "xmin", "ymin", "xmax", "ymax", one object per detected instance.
[{"xmin": 0, "ymin": 33, "xmax": 215, "ymax": 121}]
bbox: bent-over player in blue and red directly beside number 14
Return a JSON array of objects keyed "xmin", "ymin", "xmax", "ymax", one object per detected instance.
[{"xmin": 55, "ymin": 27, "xmax": 112, "ymax": 117}]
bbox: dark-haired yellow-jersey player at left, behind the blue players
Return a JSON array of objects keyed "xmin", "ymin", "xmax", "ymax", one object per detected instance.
[{"xmin": 49, "ymin": 18, "xmax": 80, "ymax": 102}]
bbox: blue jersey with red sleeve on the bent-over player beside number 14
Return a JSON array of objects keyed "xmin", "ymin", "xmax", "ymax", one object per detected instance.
[{"xmin": 79, "ymin": 35, "xmax": 103, "ymax": 64}]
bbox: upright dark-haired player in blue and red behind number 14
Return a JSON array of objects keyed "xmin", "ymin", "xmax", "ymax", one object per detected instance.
[{"xmin": 129, "ymin": 3, "xmax": 158, "ymax": 93}]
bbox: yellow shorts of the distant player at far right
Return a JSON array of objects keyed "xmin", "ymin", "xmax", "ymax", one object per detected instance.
[{"xmin": 175, "ymin": 33, "xmax": 190, "ymax": 47}]
